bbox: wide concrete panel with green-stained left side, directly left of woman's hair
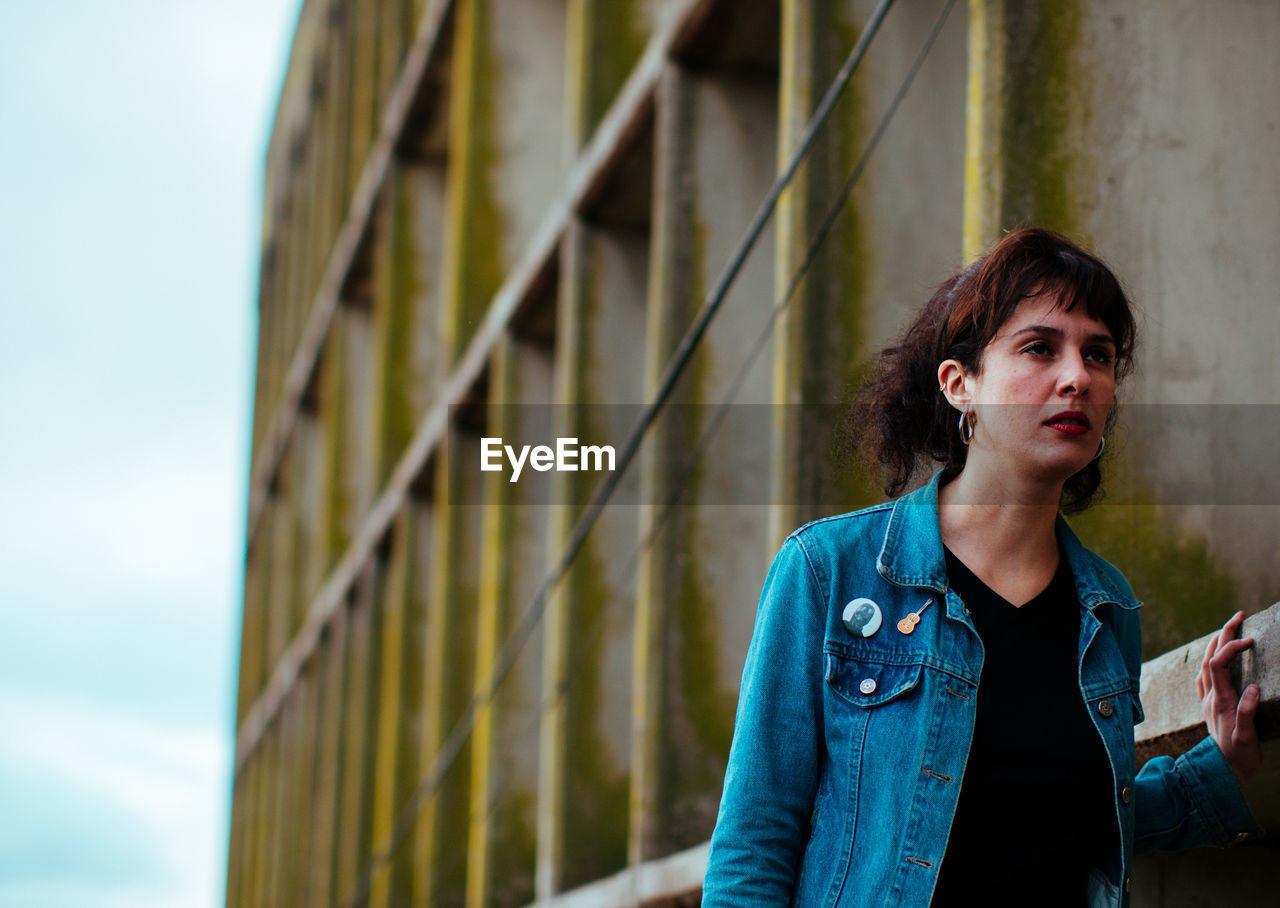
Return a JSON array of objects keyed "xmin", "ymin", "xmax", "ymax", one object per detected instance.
[{"xmin": 771, "ymin": 0, "xmax": 965, "ymax": 543}]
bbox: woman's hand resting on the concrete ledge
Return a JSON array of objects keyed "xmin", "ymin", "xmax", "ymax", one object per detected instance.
[{"xmin": 1196, "ymin": 612, "xmax": 1262, "ymax": 785}]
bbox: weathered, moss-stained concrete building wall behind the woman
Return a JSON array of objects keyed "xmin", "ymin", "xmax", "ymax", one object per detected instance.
[{"xmin": 227, "ymin": 0, "xmax": 1280, "ymax": 908}]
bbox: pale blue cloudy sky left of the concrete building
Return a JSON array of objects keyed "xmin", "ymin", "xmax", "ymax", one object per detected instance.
[{"xmin": 0, "ymin": 0, "xmax": 301, "ymax": 908}]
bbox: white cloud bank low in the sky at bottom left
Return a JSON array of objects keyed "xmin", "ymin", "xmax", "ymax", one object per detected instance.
[{"xmin": 0, "ymin": 690, "xmax": 230, "ymax": 905}]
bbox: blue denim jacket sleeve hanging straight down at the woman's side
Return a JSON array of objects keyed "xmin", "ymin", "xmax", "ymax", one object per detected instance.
[{"xmin": 701, "ymin": 537, "xmax": 827, "ymax": 908}]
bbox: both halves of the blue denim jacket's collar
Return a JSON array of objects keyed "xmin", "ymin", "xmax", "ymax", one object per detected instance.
[{"xmin": 876, "ymin": 470, "xmax": 1142, "ymax": 610}]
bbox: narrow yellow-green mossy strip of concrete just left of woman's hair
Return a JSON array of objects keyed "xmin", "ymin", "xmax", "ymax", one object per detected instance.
[{"xmin": 769, "ymin": 0, "xmax": 877, "ymax": 543}]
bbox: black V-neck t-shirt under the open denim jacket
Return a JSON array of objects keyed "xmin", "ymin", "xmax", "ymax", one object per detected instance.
[{"xmin": 933, "ymin": 551, "xmax": 1115, "ymax": 908}]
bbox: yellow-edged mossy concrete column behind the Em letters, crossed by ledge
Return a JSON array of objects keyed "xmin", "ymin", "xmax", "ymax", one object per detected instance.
[{"xmin": 536, "ymin": 24, "xmax": 658, "ymax": 899}]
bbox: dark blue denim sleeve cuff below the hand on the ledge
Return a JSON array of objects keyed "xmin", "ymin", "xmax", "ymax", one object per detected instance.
[{"xmin": 1134, "ymin": 736, "xmax": 1261, "ymax": 854}]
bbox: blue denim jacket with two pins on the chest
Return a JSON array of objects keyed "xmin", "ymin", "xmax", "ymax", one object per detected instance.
[{"xmin": 703, "ymin": 475, "xmax": 1256, "ymax": 908}]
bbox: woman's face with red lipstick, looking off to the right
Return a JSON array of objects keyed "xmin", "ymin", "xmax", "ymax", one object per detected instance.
[{"xmin": 963, "ymin": 295, "xmax": 1116, "ymax": 482}]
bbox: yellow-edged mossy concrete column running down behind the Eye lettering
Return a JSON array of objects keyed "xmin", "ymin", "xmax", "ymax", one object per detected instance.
[{"xmin": 466, "ymin": 336, "xmax": 552, "ymax": 908}]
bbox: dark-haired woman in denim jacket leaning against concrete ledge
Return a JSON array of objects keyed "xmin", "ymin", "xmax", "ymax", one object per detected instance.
[{"xmin": 703, "ymin": 229, "xmax": 1260, "ymax": 908}]
